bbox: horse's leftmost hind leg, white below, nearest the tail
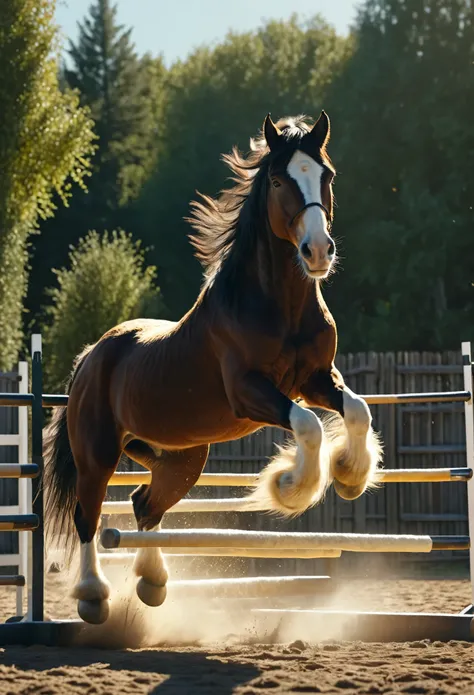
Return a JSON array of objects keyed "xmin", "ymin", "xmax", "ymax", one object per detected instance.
[{"xmin": 72, "ymin": 427, "xmax": 120, "ymax": 624}]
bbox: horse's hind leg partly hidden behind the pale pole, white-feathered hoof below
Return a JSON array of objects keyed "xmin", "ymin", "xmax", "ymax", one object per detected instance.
[{"xmin": 125, "ymin": 445, "xmax": 209, "ymax": 606}]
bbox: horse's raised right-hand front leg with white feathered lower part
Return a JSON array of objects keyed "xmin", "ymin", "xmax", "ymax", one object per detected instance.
[{"xmin": 301, "ymin": 368, "xmax": 382, "ymax": 500}]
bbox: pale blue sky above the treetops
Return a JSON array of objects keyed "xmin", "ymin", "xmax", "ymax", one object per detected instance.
[{"xmin": 56, "ymin": 0, "xmax": 360, "ymax": 65}]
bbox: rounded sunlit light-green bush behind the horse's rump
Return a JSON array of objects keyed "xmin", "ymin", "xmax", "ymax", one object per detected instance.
[{"xmin": 43, "ymin": 230, "xmax": 164, "ymax": 390}]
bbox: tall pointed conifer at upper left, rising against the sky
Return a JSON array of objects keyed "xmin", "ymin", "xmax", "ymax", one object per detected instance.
[{"xmin": 65, "ymin": 0, "xmax": 159, "ymax": 214}]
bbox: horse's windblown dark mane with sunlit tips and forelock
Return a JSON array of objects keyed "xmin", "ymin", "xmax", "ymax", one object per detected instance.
[{"xmin": 188, "ymin": 115, "xmax": 311, "ymax": 280}]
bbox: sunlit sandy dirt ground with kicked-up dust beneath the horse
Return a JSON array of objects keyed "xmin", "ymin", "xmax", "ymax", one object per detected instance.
[{"xmin": 0, "ymin": 574, "xmax": 474, "ymax": 695}]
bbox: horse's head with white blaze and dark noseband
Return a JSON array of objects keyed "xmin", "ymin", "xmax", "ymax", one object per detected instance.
[{"xmin": 263, "ymin": 111, "xmax": 336, "ymax": 280}]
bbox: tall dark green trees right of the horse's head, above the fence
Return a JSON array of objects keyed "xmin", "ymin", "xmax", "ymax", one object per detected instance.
[{"xmin": 328, "ymin": 0, "xmax": 474, "ymax": 350}]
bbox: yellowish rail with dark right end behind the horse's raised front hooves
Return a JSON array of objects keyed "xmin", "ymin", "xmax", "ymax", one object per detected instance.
[{"xmin": 105, "ymin": 467, "xmax": 472, "ymax": 490}]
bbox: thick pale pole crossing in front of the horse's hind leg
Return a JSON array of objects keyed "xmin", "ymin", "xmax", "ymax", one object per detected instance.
[{"xmin": 101, "ymin": 528, "xmax": 440, "ymax": 553}]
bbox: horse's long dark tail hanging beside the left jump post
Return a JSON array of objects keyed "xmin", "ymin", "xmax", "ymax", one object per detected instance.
[{"xmin": 43, "ymin": 345, "xmax": 93, "ymax": 560}]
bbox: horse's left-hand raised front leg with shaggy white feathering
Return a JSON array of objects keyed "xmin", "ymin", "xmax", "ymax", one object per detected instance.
[{"xmin": 226, "ymin": 372, "xmax": 329, "ymax": 516}]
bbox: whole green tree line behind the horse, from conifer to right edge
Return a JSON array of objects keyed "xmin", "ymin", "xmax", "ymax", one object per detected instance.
[{"xmin": 25, "ymin": 0, "xmax": 474, "ymax": 351}]
